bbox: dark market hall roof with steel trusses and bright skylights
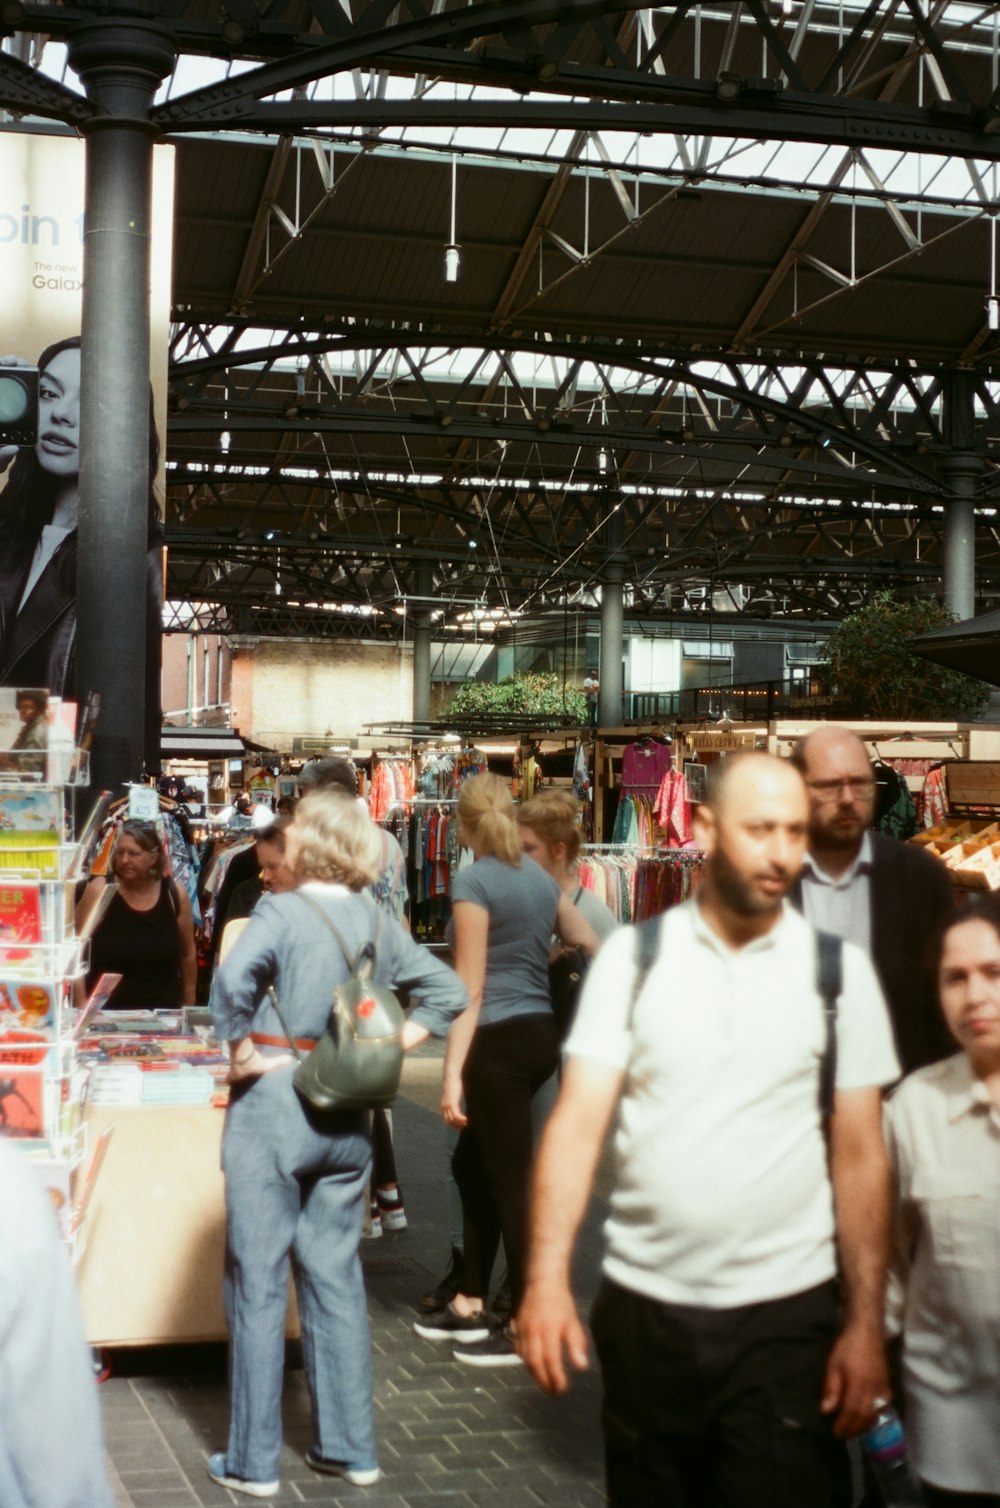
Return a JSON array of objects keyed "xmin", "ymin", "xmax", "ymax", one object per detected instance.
[{"xmin": 0, "ymin": 0, "xmax": 1000, "ymax": 635}]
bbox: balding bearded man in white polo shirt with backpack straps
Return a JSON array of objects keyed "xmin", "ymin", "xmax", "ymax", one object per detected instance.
[{"xmin": 517, "ymin": 754, "xmax": 899, "ymax": 1508}]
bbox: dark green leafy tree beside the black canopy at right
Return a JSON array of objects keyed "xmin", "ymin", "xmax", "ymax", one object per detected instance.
[{"xmin": 822, "ymin": 591, "xmax": 992, "ymax": 722}]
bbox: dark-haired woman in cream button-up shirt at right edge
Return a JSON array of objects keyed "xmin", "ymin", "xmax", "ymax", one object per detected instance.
[{"xmin": 885, "ymin": 897, "xmax": 1000, "ymax": 1508}]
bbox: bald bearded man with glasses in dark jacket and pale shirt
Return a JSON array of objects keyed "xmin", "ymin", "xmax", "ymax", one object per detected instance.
[{"xmin": 789, "ymin": 724, "xmax": 955, "ymax": 1074}]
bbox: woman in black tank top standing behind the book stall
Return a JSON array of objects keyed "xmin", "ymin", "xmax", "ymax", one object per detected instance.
[{"xmin": 77, "ymin": 822, "xmax": 196, "ymax": 1010}]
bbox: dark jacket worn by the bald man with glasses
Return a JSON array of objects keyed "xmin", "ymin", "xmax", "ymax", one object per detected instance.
[{"xmin": 789, "ymin": 832, "xmax": 958, "ymax": 1074}]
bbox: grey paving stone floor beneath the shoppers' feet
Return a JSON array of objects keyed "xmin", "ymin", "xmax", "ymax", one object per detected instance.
[{"xmin": 101, "ymin": 1045, "xmax": 603, "ymax": 1508}]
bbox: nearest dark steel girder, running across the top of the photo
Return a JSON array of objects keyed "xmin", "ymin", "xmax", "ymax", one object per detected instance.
[{"xmin": 0, "ymin": 0, "xmax": 1000, "ymax": 160}]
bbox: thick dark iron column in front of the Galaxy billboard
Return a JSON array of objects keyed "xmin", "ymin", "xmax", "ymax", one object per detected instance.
[{"xmin": 69, "ymin": 18, "xmax": 175, "ymax": 789}]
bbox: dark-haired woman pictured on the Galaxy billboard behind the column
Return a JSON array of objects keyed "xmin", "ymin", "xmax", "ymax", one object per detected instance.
[{"xmin": 0, "ymin": 335, "xmax": 161, "ymax": 695}]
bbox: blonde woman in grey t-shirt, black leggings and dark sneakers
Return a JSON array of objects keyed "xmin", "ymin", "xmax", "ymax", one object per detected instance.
[{"xmin": 415, "ymin": 775, "xmax": 597, "ymax": 1366}]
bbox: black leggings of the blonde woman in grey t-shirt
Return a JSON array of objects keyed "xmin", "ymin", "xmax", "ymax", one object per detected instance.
[{"xmin": 451, "ymin": 1015, "xmax": 560, "ymax": 1310}]
